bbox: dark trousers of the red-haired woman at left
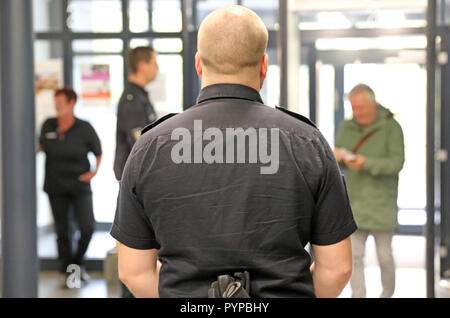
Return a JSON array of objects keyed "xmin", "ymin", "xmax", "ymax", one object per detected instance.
[{"xmin": 49, "ymin": 193, "xmax": 95, "ymax": 273}]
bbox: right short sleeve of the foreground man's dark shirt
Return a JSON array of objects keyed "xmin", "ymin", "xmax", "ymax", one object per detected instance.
[{"xmin": 311, "ymin": 136, "xmax": 357, "ymax": 245}]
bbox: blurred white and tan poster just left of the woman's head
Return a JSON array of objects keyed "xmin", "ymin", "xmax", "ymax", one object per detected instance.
[{"xmin": 34, "ymin": 59, "xmax": 63, "ymax": 130}]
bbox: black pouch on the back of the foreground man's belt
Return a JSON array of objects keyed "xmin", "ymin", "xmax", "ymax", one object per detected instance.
[{"xmin": 208, "ymin": 271, "xmax": 250, "ymax": 298}]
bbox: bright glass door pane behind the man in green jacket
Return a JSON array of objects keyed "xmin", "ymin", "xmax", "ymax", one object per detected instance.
[{"xmin": 344, "ymin": 64, "xmax": 426, "ymax": 208}]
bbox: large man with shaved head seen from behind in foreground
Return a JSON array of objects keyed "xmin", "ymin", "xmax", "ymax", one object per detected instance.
[{"xmin": 111, "ymin": 6, "xmax": 356, "ymax": 297}]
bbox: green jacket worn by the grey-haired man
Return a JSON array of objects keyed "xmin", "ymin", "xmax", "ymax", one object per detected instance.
[{"xmin": 335, "ymin": 105, "xmax": 405, "ymax": 230}]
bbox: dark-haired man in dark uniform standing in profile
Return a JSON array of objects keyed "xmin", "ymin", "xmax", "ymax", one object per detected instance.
[{"xmin": 114, "ymin": 47, "xmax": 158, "ymax": 298}]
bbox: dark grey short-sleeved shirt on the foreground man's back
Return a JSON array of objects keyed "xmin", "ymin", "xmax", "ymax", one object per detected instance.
[{"xmin": 111, "ymin": 84, "xmax": 356, "ymax": 297}]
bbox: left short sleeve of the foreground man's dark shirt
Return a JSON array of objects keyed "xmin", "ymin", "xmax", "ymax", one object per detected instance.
[{"xmin": 110, "ymin": 148, "xmax": 160, "ymax": 250}]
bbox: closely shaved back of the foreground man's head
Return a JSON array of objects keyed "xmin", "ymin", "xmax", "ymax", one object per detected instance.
[{"xmin": 198, "ymin": 5, "xmax": 268, "ymax": 76}]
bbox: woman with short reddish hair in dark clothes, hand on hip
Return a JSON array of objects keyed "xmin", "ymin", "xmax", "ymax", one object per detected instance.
[{"xmin": 39, "ymin": 87, "xmax": 102, "ymax": 281}]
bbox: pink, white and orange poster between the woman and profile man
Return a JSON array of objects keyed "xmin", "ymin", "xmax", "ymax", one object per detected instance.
[{"xmin": 81, "ymin": 64, "xmax": 111, "ymax": 106}]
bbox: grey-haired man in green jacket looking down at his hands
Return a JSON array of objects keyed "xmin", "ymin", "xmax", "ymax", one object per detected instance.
[{"xmin": 334, "ymin": 84, "xmax": 405, "ymax": 298}]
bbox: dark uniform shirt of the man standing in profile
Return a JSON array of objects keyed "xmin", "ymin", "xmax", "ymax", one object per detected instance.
[{"xmin": 114, "ymin": 82, "xmax": 156, "ymax": 180}]
